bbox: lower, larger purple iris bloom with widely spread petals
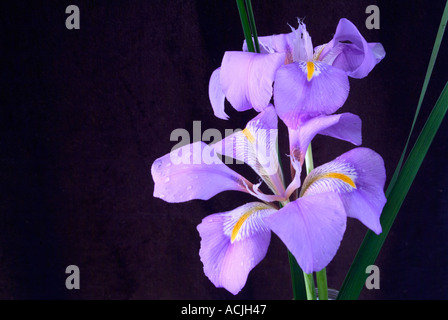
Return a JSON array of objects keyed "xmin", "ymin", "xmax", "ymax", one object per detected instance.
[{"xmin": 151, "ymin": 105, "xmax": 386, "ymax": 294}]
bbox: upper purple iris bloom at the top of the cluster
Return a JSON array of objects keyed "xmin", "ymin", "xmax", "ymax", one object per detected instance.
[{"xmin": 209, "ymin": 19, "xmax": 385, "ymax": 129}]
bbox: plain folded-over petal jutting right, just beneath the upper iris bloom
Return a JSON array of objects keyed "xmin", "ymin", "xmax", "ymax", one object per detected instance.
[{"xmin": 288, "ymin": 113, "xmax": 362, "ymax": 164}]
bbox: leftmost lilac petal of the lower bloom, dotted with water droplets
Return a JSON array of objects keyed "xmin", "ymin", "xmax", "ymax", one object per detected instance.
[{"xmin": 151, "ymin": 141, "xmax": 252, "ymax": 203}]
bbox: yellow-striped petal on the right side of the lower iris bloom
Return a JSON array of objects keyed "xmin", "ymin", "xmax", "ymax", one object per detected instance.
[{"xmin": 301, "ymin": 148, "xmax": 386, "ymax": 234}]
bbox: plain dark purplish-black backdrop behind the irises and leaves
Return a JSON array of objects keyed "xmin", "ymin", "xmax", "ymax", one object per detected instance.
[{"xmin": 0, "ymin": 0, "xmax": 448, "ymax": 299}]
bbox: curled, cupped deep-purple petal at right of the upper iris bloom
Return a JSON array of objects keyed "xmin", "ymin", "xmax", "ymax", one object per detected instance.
[{"xmin": 320, "ymin": 19, "xmax": 386, "ymax": 79}]
